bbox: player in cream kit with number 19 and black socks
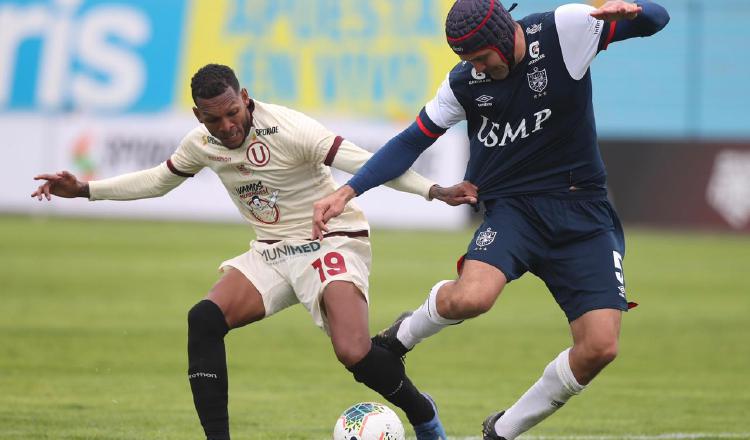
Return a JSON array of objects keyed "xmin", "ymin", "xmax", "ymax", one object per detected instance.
[{"xmin": 32, "ymin": 64, "xmax": 476, "ymax": 440}]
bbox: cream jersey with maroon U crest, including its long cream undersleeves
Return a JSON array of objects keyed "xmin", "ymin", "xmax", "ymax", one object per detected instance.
[{"xmin": 89, "ymin": 101, "xmax": 434, "ymax": 240}]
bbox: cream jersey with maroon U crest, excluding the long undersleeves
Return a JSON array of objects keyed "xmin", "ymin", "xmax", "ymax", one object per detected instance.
[{"xmin": 167, "ymin": 101, "xmax": 369, "ymax": 239}]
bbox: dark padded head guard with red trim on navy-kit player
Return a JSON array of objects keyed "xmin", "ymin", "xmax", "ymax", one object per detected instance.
[{"xmin": 445, "ymin": 0, "xmax": 516, "ymax": 68}]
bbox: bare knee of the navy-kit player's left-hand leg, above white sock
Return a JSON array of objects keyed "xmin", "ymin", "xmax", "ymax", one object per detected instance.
[{"xmin": 437, "ymin": 260, "xmax": 507, "ymax": 319}]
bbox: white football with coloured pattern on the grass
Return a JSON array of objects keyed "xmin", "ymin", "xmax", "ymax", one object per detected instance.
[{"xmin": 333, "ymin": 402, "xmax": 404, "ymax": 440}]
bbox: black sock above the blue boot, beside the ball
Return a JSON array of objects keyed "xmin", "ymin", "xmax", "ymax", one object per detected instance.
[{"xmin": 349, "ymin": 344, "xmax": 435, "ymax": 425}]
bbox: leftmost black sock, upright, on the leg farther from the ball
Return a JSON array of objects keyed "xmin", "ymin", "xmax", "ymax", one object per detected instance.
[{"xmin": 188, "ymin": 299, "xmax": 229, "ymax": 440}]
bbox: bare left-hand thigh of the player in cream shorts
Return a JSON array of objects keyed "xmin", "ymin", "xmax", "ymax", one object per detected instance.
[{"xmin": 206, "ymin": 268, "xmax": 266, "ymax": 328}]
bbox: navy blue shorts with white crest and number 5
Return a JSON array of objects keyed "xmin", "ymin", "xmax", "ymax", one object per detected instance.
[{"xmin": 466, "ymin": 194, "xmax": 628, "ymax": 321}]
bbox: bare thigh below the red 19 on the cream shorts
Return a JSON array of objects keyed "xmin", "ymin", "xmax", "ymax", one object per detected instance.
[{"xmin": 321, "ymin": 281, "xmax": 370, "ymax": 367}]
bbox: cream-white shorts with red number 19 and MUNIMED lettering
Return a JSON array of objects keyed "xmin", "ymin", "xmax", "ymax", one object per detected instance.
[{"xmin": 219, "ymin": 236, "xmax": 372, "ymax": 333}]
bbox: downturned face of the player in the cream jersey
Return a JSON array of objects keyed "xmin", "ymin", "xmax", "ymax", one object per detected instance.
[{"xmin": 193, "ymin": 87, "xmax": 251, "ymax": 149}]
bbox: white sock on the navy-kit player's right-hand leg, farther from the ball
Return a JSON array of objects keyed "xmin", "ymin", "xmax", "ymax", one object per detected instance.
[{"xmin": 495, "ymin": 348, "xmax": 585, "ymax": 440}]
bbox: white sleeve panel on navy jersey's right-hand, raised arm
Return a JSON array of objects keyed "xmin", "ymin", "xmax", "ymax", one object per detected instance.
[{"xmin": 555, "ymin": 4, "xmax": 605, "ymax": 80}]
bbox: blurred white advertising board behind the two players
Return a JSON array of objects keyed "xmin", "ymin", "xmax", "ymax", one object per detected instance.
[{"xmin": 0, "ymin": 113, "xmax": 469, "ymax": 229}]
